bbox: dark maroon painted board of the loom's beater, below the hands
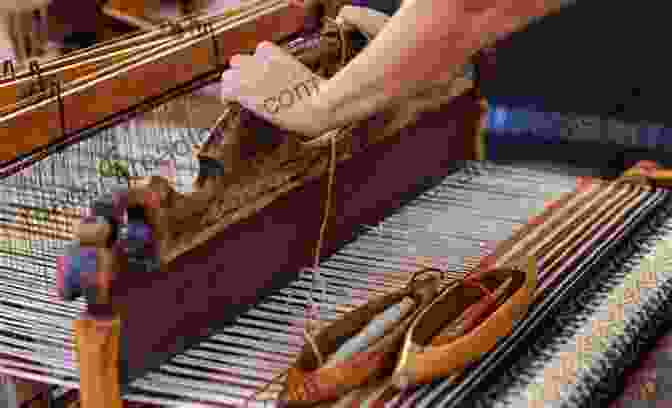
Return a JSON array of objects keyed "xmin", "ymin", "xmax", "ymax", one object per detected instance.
[{"xmin": 114, "ymin": 95, "xmax": 478, "ymax": 383}]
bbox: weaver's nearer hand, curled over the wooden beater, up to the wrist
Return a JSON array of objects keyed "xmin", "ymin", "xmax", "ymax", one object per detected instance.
[{"xmin": 221, "ymin": 42, "xmax": 323, "ymax": 137}]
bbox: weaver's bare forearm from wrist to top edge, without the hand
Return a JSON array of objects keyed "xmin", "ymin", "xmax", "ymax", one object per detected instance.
[{"xmin": 310, "ymin": 0, "xmax": 558, "ymax": 135}]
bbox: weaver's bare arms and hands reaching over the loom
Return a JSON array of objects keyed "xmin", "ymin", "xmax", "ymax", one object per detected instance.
[{"xmin": 221, "ymin": 0, "xmax": 561, "ymax": 139}]
